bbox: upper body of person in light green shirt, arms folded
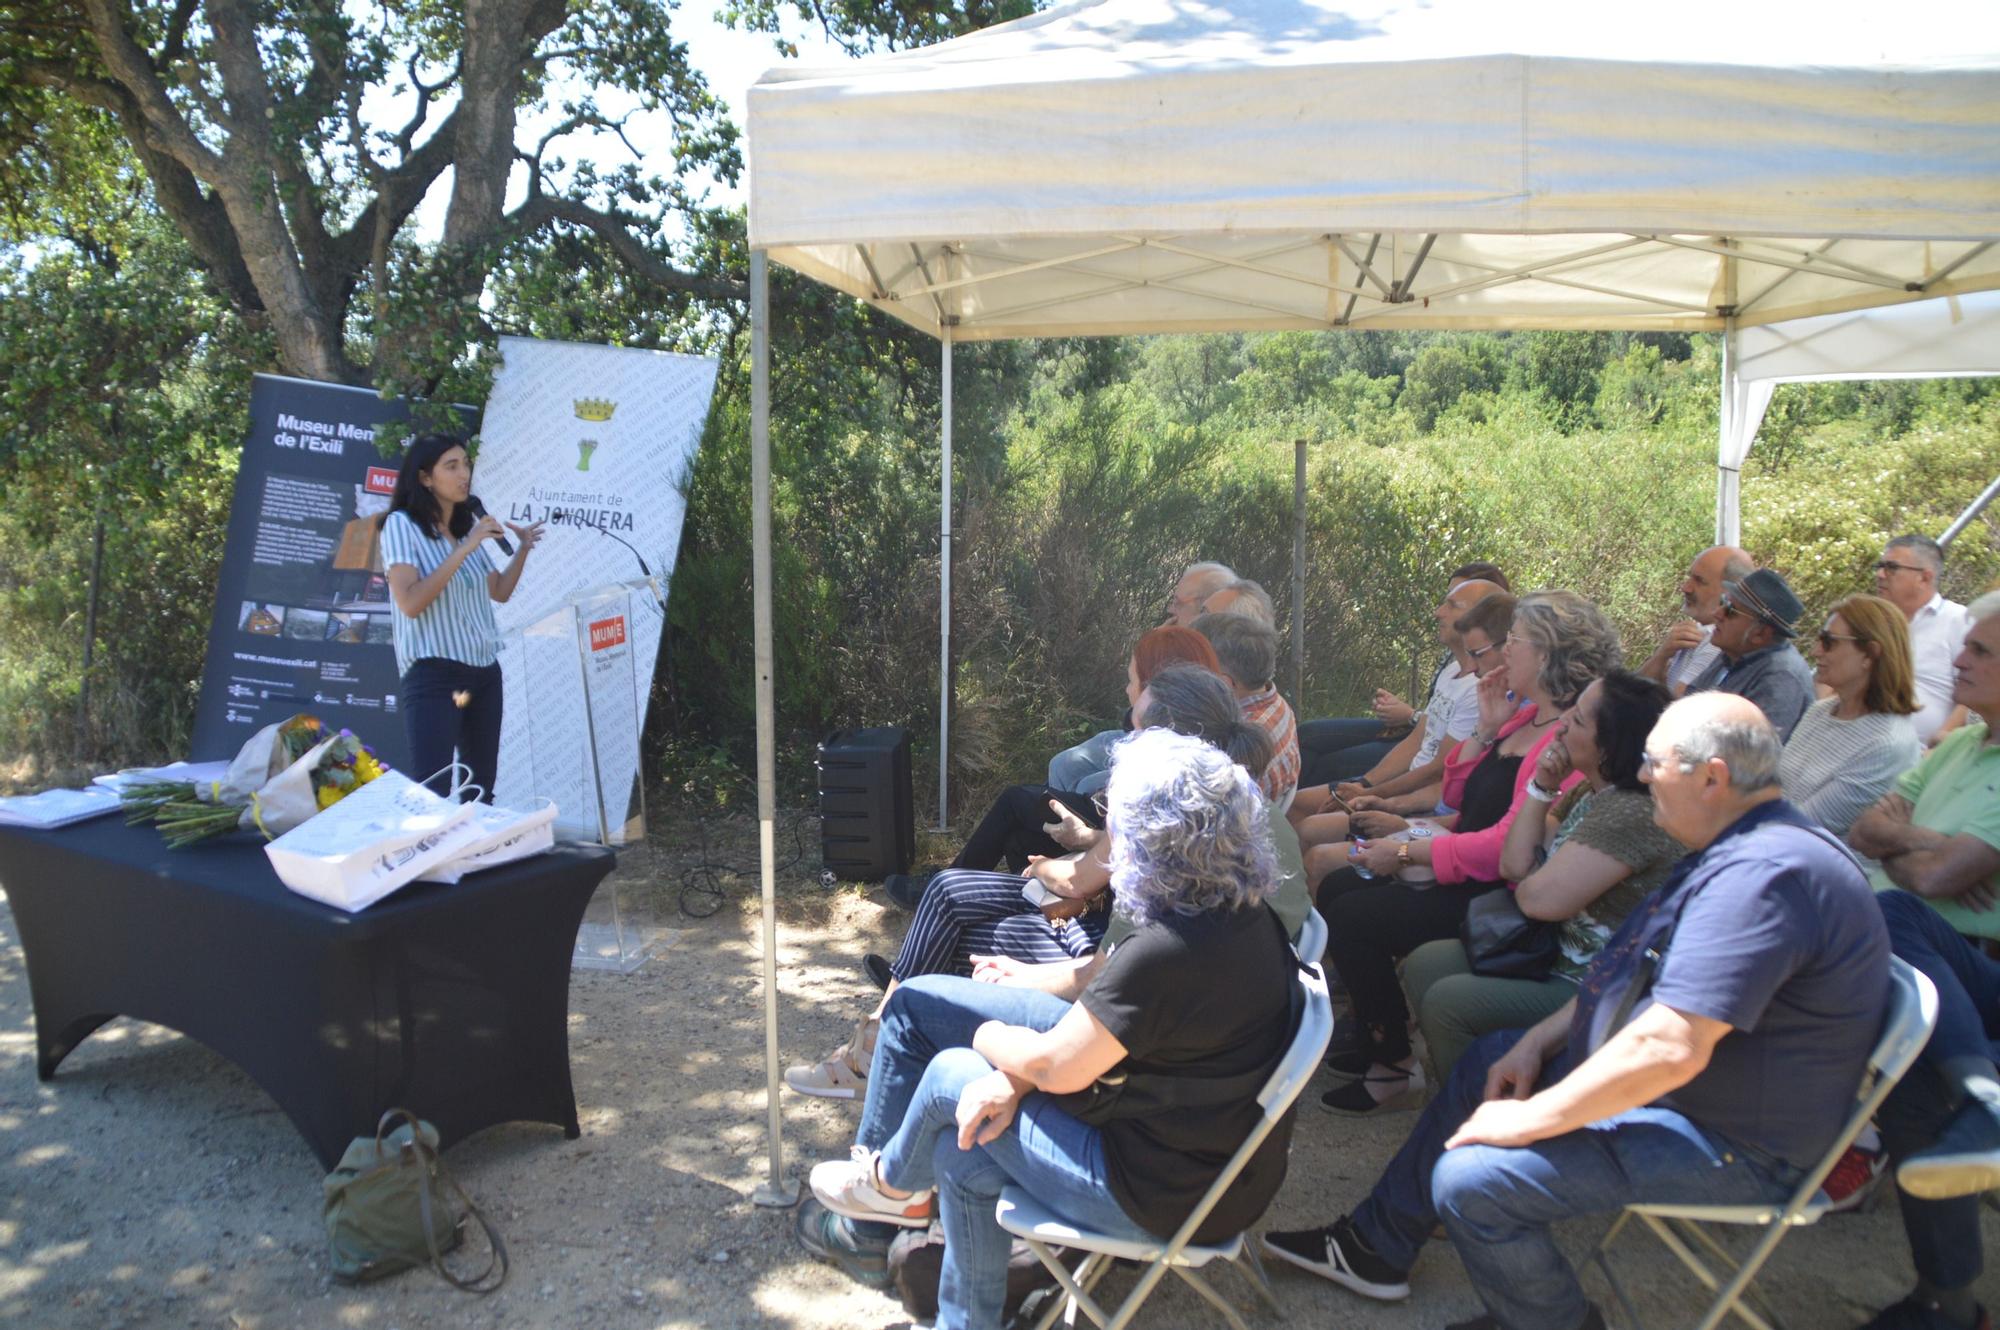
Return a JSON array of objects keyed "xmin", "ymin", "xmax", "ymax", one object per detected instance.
[{"xmin": 1848, "ymin": 592, "xmax": 2000, "ymax": 938}]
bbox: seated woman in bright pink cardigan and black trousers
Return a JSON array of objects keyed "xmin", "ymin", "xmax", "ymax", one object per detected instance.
[{"xmin": 1320, "ymin": 590, "xmax": 1620, "ymax": 1116}]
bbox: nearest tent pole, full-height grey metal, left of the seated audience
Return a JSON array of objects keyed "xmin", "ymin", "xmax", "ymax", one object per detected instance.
[{"xmin": 750, "ymin": 250, "xmax": 798, "ymax": 1206}]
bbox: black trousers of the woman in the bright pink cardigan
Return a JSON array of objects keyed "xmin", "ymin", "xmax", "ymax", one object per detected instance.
[{"xmin": 1320, "ymin": 868, "xmax": 1494, "ymax": 1064}]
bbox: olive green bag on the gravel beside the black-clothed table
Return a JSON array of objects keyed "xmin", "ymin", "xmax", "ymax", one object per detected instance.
[{"xmin": 324, "ymin": 1108, "xmax": 508, "ymax": 1294}]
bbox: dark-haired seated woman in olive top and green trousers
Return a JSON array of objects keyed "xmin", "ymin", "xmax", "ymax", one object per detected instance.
[{"xmin": 1402, "ymin": 672, "xmax": 1686, "ymax": 1084}]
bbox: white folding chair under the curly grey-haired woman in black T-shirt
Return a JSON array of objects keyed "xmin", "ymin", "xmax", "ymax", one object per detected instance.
[{"xmin": 996, "ymin": 948, "xmax": 1334, "ymax": 1330}]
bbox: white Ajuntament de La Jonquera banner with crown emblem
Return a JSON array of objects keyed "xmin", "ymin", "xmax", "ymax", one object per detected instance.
[{"xmin": 472, "ymin": 338, "xmax": 716, "ymax": 824}]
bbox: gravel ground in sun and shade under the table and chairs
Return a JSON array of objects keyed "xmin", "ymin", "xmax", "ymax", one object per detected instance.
[{"xmin": 0, "ymin": 826, "xmax": 2000, "ymax": 1330}]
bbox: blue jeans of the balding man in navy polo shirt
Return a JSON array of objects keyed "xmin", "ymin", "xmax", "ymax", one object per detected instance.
[{"xmin": 1354, "ymin": 1030, "xmax": 1802, "ymax": 1330}]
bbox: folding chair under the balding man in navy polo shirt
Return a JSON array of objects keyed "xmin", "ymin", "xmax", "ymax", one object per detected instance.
[{"xmin": 1592, "ymin": 958, "xmax": 1938, "ymax": 1330}]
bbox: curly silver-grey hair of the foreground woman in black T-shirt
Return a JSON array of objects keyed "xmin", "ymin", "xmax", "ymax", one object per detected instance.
[{"xmin": 1104, "ymin": 730, "xmax": 1278, "ymax": 926}]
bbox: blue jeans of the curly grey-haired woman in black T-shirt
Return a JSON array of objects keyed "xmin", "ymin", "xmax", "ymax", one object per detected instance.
[{"xmin": 854, "ymin": 974, "xmax": 1152, "ymax": 1330}]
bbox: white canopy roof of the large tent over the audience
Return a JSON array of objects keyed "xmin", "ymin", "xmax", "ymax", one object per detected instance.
[{"xmin": 748, "ymin": 0, "xmax": 2000, "ymax": 340}]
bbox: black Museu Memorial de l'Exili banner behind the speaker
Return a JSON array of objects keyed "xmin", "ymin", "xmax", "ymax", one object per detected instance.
[{"xmin": 192, "ymin": 374, "xmax": 472, "ymax": 768}]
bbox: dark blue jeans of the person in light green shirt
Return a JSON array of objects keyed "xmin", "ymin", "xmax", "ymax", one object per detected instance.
[{"xmin": 1876, "ymin": 892, "xmax": 2000, "ymax": 1288}]
